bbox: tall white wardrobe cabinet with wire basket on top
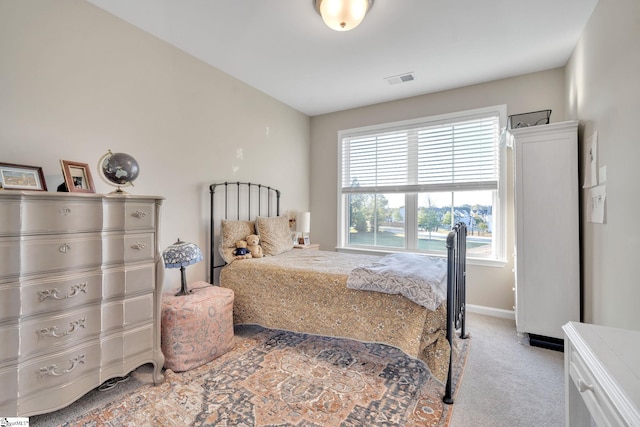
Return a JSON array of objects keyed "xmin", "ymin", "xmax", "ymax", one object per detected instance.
[{"xmin": 508, "ymin": 121, "xmax": 580, "ymax": 343}]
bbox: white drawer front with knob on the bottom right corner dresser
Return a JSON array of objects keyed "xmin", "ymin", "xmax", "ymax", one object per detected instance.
[{"xmin": 569, "ymin": 345, "xmax": 625, "ymax": 427}]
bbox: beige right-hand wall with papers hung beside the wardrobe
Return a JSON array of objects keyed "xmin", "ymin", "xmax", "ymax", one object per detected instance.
[{"xmin": 566, "ymin": 0, "xmax": 640, "ymax": 330}]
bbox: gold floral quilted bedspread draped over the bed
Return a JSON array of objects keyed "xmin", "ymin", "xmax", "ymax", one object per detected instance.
[{"xmin": 220, "ymin": 249, "xmax": 450, "ymax": 383}]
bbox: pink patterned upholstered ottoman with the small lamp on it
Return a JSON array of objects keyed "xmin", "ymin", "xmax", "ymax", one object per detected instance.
[{"xmin": 161, "ymin": 282, "xmax": 234, "ymax": 372}]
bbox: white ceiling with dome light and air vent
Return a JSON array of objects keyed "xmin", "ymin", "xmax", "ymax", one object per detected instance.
[{"xmin": 88, "ymin": 0, "xmax": 597, "ymax": 116}]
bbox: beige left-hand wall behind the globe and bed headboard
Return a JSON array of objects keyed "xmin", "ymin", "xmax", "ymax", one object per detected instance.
[{"xmin": 0, "ymin": 0, "xmax": 309, "ymax": 286}]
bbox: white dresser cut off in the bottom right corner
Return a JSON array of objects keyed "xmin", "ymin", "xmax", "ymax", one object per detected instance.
[{"xmin": 563, "ymin": 322, "xmax": 640, "ymax": 427}]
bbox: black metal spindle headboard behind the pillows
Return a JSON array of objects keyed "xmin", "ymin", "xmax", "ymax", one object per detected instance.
[{"xmin": 209, "ymin": 181, "xmax": 280, "ymax": 284}]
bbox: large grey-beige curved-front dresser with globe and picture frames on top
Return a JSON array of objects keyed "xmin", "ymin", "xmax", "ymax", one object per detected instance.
[{"xmin": 0, "ymin": 190, "xmax": 164, "ymax": 416}]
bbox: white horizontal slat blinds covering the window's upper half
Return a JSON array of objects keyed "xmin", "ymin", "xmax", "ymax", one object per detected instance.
[{"xmin": 342, "ymin": 112, "xmax": 500, "ymax": 193}]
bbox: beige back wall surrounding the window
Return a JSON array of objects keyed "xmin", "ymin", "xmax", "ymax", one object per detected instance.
[{"xmin": 311, "ymin": 69, "xmax": 565, "ymax": 310}]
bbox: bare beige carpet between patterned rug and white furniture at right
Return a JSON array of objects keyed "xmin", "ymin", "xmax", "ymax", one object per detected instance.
[{"xmin": 451, "ymin": 313, "xmax": 564, "ymax": 427}]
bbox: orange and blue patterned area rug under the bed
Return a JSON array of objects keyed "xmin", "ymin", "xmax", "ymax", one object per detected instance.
[{"xmin": 63, "ymin": 328, "xmax": 469, "ymax": 427}]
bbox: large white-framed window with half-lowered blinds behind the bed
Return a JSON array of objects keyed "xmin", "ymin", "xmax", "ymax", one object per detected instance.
[{"xmin": 338, "ymin": 106, "xmax": 506, "ymax": 260}]
